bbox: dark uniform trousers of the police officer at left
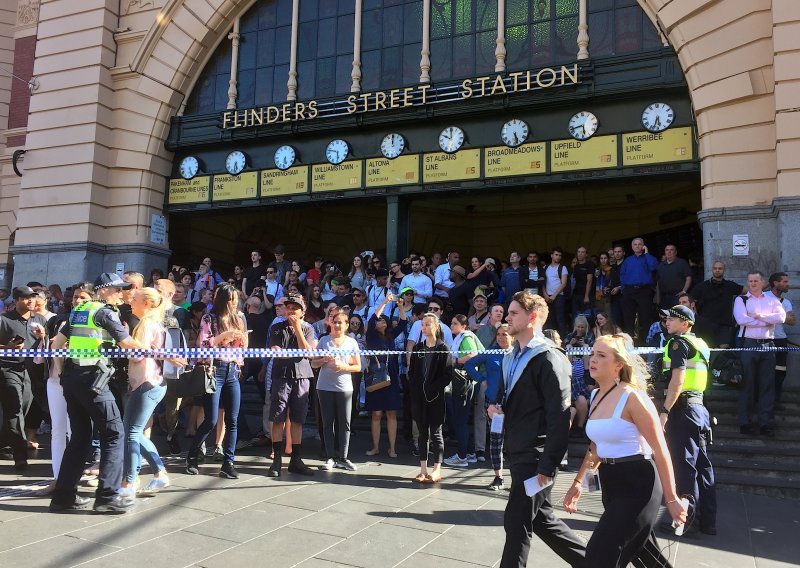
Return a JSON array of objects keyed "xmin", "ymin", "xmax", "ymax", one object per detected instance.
[{"xmin": 53, "ymin": 366, "xmax": 125, "ymax": 505}]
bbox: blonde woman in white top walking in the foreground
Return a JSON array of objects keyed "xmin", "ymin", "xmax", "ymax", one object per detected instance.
[{"xmin": 564, "ymin": 334, "xmax": 686, "ymax": 568}]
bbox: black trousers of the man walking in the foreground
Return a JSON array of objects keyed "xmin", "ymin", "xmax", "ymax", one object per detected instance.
[{"xmin": 500, "ymin": 463, "xmax": 586, "ymax": 568}]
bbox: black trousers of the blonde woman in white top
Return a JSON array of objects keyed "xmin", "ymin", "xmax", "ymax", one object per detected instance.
[{"xmin": 586, "ymin": 460, "xmax": 670, "ymax": 568}]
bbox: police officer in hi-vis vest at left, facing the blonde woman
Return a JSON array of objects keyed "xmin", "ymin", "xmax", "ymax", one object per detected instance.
[{"xmin": 50, "ymin": 273, "xmax": 143, "ymax": 513}]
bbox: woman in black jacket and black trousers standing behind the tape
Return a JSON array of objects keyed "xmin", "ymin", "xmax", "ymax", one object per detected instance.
[{"xmin": 408, "ymin": 312, "xmax": 453, "ymax": 483}]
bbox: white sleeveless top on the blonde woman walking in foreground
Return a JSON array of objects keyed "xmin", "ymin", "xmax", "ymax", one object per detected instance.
[{"xmin": 586, "ymin": 390, "xmax": 653, "ymax": 458}]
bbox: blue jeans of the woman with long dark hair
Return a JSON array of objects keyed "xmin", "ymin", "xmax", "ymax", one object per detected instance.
[{"xmin": 189, "ymin": 361, "xmax": 242, "ymax": 463}]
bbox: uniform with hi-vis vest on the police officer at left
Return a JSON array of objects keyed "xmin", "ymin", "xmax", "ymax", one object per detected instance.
[{"xmin": 51, "ymin": 301, "xmax": 129, "ymax": 508}]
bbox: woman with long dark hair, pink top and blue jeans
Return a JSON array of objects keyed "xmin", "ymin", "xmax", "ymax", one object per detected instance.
[{"xmin": 186, "ymin": 283, "xmax": 247, "ymax": 479}]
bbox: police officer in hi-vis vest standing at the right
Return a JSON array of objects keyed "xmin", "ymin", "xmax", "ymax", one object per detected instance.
[{"xmin": 660, "ymin": 305, "xmax": 717, "ymax": 535}]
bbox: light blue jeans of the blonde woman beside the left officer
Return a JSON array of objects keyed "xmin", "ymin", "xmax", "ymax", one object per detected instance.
[{"xmin": 122, "ymin": 381, "xmax": 167, "ymax": 483}]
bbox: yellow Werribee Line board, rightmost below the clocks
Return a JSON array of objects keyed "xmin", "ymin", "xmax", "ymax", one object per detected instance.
[{"xmin": 621, "ymin": 126, "xmax": 694, "ymax": 166}]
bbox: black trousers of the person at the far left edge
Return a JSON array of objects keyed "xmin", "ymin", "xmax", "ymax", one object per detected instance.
[{"xmin": 0, "ymin": 367, "xmax": 32, "ymax": 462}]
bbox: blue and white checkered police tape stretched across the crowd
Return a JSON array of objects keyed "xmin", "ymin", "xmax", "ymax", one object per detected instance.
[{"xmin": 0, "ymin": 347, "xmax": 800, "ymax": 359}]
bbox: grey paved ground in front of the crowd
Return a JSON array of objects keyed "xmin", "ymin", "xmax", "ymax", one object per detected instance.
[{"xmin": 0, "ymin": 433, "xmax": 800, "ymax": 568}]
